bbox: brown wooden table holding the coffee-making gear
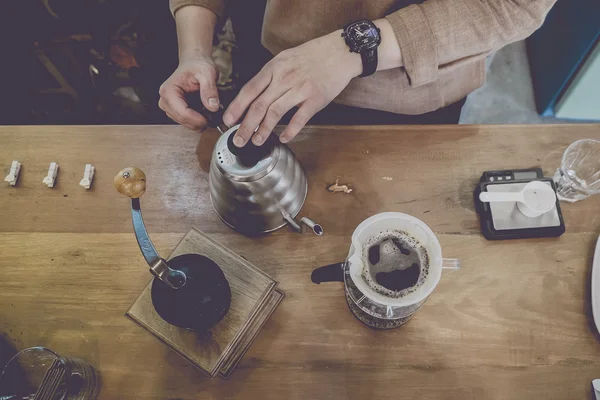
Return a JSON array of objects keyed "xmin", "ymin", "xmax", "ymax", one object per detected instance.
[{"xmin": 0, "ymin": 125, "xmax": 600, "ymax": 400}]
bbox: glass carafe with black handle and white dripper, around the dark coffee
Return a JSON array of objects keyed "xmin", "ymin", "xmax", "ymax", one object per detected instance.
[{"xmin": 312, "ymin": 212, "xmax": 460, "ymax": 329}]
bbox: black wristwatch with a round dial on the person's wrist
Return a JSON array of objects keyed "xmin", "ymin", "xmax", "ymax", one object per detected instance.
[{"xmin": 342, "ymin": 19, "xmax": 381, "ymax": 77}]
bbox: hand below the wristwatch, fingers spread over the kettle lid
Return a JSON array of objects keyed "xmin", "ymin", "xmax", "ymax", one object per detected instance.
[{"xmin": 223, "ymin": 31, "xmax": 362, "ymax": 147}]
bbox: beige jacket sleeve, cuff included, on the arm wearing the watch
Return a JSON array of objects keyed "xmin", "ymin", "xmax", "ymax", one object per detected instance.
[{"xmin": 387, "ymin": 0, "xmax": 556, "ymax": 87}]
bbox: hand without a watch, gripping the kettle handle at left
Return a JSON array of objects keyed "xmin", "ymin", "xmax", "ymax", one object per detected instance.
[{"xmin": 158, "ymin": 56, "xmax": 219, "ymax": 132}]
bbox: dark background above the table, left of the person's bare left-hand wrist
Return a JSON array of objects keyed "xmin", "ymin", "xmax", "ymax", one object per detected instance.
[{"xmin": 0, "ymin": 0, "xmax": 177, "ymax": 124}]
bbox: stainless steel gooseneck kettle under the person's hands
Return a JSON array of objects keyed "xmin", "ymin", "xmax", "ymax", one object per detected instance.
[{"xmin": 199, "ymin": 95, "xmax": 323, "ymax": 235}]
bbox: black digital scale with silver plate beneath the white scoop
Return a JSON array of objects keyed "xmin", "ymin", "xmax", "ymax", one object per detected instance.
[{"xmin": 474, "ymin": 168, "xmax": 565, "ymax": 240}]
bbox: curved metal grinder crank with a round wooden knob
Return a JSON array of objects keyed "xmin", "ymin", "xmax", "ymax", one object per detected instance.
[{"xmin": 114, "ymin": 167, "xmax": 187, "ymax": 289}]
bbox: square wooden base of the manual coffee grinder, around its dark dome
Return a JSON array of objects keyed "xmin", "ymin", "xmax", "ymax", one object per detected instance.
[{"xmin": 127, "ymin": 229, "xmax": 277, "ymax": 376}]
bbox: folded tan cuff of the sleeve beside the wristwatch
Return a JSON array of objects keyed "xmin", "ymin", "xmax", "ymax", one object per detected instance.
[{"xmin": 386, "ymin": 4, "xmax": 438, "ymax": 87}]
